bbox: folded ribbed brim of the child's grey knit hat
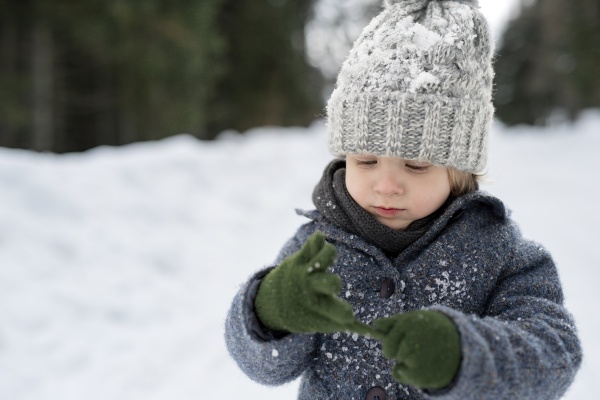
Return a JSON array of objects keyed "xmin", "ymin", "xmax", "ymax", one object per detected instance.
[{"xmin": 327, "ymin": 90, "xmax": 494, "ymax": 173}]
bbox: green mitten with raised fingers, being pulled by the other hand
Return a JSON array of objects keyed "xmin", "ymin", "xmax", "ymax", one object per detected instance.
[{"xmin": 254, "ymin": 232, "xmax": 372, "ymax": 333}]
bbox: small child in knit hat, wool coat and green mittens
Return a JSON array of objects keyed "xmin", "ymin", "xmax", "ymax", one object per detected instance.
[{"xmin": 226, "ymin": 0, "xmax": 581, "ymax": 400}]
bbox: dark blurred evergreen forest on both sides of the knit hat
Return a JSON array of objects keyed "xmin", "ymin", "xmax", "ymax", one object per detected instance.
[{"xmin": 0, "ymin": 0, "xmax": 600, "ymax": 153}]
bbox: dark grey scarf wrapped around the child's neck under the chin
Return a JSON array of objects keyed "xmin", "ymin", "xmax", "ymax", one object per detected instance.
[{"xmin": 313, "ymin": 159, "xmax": 450, "ymax": 257}]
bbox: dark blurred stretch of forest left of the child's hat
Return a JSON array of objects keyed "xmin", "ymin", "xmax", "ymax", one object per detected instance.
[{"xmin": 0, "ymin": 0, "xmax": 322, "ymax": 152}]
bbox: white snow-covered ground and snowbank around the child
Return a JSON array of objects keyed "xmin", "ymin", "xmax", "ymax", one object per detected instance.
[{"xmin": 0, "ymin": 111, "xmax": 600, "ymax": 400}]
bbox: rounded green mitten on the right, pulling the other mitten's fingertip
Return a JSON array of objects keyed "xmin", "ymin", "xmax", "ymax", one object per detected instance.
[{"xmin": 374, "ymin": 310, "xmax": 461, "ymax": 389}]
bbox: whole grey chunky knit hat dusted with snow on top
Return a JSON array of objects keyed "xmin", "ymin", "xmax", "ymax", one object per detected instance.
[{"xmin": 327, "ymin": 0, "xmax": 494, "ymax": 173}]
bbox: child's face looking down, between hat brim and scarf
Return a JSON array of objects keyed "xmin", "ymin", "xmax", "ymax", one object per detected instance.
[{"xmin": 346, "ymin": 154, "xmax": 450, "ymax": 230}]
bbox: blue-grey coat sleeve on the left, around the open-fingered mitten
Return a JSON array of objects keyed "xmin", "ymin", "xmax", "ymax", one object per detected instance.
[{"xmin": 225, "ymin": 224, "xmax": 316, "ymax": 385}]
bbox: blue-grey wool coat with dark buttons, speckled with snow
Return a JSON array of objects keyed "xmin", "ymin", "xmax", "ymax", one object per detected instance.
[{"xmin": 225, "ymin": 192, "xmax": 582, "ymax": 400}]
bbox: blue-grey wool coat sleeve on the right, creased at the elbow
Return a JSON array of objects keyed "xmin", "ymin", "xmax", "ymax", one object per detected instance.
[{"xmin": 432, "ymin": 231, "xmax": 582, "ymax": 400}]
